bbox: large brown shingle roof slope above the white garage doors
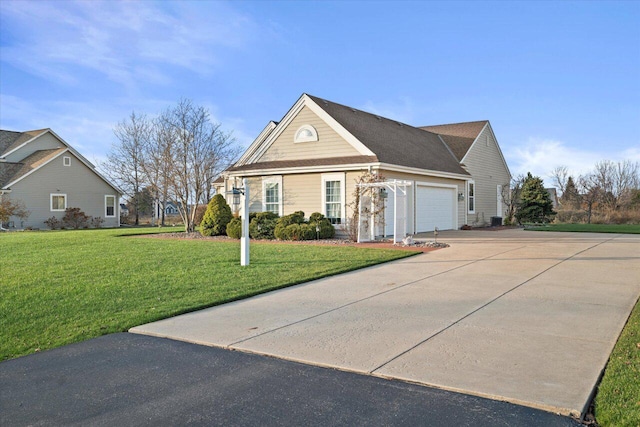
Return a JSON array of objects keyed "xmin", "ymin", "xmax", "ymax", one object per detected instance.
[{"xmin": 308, "ymin": 95, "xmax": 468, "ymax": 175}]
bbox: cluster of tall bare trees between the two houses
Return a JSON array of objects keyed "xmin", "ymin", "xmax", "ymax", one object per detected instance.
[{"xmin": 101, "ymin": 99, "xmax": 240, "ymax": 232}]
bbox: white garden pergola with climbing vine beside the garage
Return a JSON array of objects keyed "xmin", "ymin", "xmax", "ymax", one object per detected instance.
[{"xmin": 356, "ymin": 179, "xmax": 411, "ymax": 243}]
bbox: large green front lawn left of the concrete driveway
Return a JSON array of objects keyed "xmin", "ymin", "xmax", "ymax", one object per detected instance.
[{"xmin": 0, "ymin": 228, "xmax": 415, "ymax": 360}]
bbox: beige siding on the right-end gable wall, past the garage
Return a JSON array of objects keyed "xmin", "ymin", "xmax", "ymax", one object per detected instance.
[{"xmin": 463, "ymin": 125, "xmax": 511, "ymax": 226}]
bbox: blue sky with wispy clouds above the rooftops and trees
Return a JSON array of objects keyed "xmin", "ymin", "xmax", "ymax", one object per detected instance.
[{"xmin": 0, "ymin": 0, "xmax": 640, "ymax": 183}]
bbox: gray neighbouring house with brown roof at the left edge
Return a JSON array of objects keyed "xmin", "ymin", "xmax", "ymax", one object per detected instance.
[{"xmin": 0, "ymin": 129, "xmax": 121, "ymax": 228}]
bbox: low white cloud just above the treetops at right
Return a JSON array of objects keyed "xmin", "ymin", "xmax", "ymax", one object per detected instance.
[{"xmin": 502, "ymin": 137, "xmax": 640, "ymax": 186}]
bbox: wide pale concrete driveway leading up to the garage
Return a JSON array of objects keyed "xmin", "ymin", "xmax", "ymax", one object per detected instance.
[{"xmin": 130, "ymin": 230, "xmax": 640, "ymax": 417}]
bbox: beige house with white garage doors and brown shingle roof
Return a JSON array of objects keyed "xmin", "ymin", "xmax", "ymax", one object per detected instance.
[{"xmin": 218, "ymin": 94, "xmax": 511, "ymax": 235}]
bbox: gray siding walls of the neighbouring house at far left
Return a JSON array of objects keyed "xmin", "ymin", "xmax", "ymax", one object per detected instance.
[{"xmin": 9, "ymin": 152, "xmax": 120, "ymax": 229}]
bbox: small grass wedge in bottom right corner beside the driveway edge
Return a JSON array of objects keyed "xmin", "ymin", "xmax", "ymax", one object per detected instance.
[{"xmin": 595, "ymin": 301, "xmax": 640, "ymax": 427}]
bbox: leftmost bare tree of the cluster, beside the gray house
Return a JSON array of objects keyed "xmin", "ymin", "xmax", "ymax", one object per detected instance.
[{"xmin": 101, "ymin": 112, "xmax": 150, "ymax": 225}]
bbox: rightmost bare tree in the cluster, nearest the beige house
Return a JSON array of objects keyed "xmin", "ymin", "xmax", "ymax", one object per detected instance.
[{"xmin": 163, "ymin": 99, "xmax": 235, "ymax": 232}]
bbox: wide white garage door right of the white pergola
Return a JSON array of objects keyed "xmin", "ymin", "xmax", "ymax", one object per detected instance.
[{"xmin": 416, "ymin": 185, "xmax": 457, "ymax": 232}]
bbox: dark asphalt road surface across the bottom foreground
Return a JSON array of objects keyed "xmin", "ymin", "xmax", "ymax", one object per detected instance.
[{"xmin": 0, "ymin": 333, "xmax": 580, "ymax": 427}]
